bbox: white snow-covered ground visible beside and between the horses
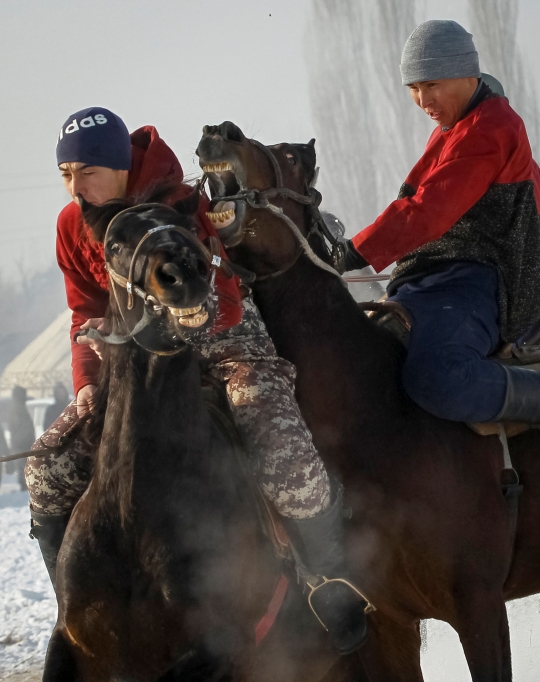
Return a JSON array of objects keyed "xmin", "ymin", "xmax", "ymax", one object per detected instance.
[{"xmin": 0, "ymin": 476, "xmax": 540, "ymax": 682}]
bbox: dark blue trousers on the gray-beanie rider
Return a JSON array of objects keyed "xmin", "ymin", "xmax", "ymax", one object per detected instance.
[{"xmin": 390, "ymin": 263, "xmax": 507, "ymax": 422}]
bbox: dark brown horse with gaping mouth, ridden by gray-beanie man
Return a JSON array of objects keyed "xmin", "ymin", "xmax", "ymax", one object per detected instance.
[{"xmin": 197, "ymin": 122, "xmax": 540, "ymax": 682}]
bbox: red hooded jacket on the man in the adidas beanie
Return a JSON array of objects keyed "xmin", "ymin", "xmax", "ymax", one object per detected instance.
[{"xmin": 56, "ymin": 126, "xmax": 242, "ymax": 395}]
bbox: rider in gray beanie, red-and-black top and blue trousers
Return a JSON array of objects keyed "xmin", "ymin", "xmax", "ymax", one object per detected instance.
[{"xmin": 342, "ymin": 21, "xmax": 540, "ymax": 424}]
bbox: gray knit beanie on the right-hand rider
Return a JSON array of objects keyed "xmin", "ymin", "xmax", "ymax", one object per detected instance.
[{"xmin": 400, "ymin": 19, "xmax": 480, "ymax": 85}]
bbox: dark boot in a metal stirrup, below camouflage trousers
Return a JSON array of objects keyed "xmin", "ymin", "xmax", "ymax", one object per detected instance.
[{"xmin": 282, "ymin": 491, "xmax": 370, "ymax": 654}]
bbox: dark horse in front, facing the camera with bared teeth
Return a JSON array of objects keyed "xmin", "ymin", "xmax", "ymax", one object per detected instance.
[{"xmin": 43, "ymin": 192, "xmax": 344, "ymax": 682}]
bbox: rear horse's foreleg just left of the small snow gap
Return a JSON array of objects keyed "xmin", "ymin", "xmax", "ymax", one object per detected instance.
[{"xmin": 358, "ymin": 611, "xmax": 424, "ymax": 682}]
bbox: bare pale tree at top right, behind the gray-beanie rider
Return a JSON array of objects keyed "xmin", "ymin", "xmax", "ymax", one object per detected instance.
[{"xmin": 469, "ymin": 0, "xmax": 540, "ymax": 152}]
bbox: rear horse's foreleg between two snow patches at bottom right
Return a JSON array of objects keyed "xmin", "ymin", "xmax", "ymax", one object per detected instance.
[{"xmin": 451, "ymin": 591, "xmax": 512, "ymax": 682}]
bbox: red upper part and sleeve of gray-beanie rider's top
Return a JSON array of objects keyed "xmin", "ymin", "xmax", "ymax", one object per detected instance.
[{"xmin": 352, "ymin": 97, "xmax": 540, "ymax": 272}]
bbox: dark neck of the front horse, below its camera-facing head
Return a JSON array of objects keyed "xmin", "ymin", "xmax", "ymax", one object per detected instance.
[{"xmin": 94, "ymin": 342, "xmax": 211, "ymax": 522}]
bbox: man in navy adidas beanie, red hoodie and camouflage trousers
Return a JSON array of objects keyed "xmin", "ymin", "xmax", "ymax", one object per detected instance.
[{"xmin": 25, "ymin": 107, "xmax": 367, "ymax": 653}]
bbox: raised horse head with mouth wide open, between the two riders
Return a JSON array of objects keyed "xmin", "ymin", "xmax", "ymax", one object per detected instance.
[{"xmin": 196, "ymin": 121, "xmax": 320, "ymax": 279}]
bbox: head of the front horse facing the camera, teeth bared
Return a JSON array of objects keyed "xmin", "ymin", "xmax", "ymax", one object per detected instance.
[{"xmin": 81, "ymin": 189, "xmax": 213, "ymax": 354}]
